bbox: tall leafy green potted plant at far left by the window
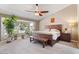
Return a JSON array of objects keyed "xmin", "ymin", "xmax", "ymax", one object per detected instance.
[{"xmin": 3, "ymin": 16, "xmax": 17, "ymax": 43}]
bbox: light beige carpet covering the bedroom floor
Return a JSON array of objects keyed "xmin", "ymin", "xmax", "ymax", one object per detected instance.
[{"xmin": 0, "ymin": 39, "xmax": 79, "ymax": 54}]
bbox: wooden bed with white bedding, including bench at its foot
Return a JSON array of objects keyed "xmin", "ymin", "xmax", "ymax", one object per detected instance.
[{"xmin": 30, "ymin": 24, "xmax": 62, "ymax": 47}]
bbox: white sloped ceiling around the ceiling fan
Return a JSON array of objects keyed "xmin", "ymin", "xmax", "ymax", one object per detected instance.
[{"xmin": 0, "ymin": 4, "xmax": 69, "ymax": 20}]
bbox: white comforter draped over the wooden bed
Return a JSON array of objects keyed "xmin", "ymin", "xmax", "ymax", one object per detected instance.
[{"xmin": 33, "ymin": 30, "xmax": 60, "ymax": 40}]
